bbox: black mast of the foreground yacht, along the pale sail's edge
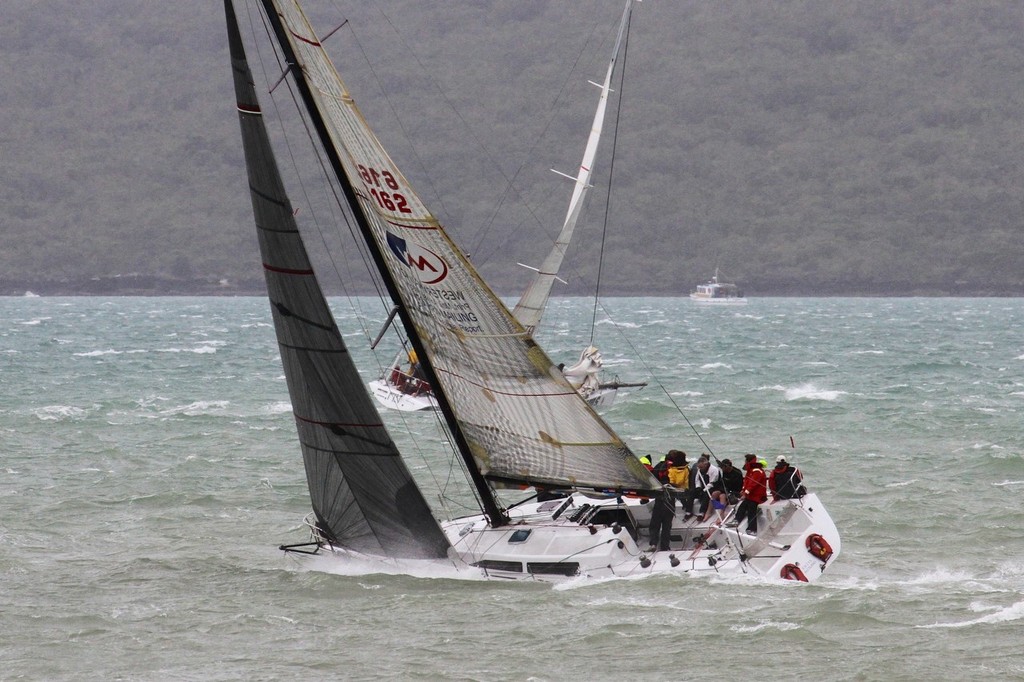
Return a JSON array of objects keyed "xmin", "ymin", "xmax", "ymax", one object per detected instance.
[{"xmin": 261, "ymin": 0, "xmax": 508, "ymax": 527}]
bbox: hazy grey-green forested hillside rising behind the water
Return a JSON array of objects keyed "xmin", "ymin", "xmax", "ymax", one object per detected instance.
[{"xmin": 0, "ymin": 0, "xmax": 1024, "ymax": 296}]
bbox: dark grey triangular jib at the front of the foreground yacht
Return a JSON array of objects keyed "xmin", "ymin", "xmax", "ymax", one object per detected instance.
[{"xmin": 224, "ymin": 0, "xmax": 449, "ymax": 558}]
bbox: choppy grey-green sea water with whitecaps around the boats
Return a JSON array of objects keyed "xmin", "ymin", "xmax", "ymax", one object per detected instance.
[{"xmin": 0, "ymin": 298, "xmax": 1024, "ymax": 680}]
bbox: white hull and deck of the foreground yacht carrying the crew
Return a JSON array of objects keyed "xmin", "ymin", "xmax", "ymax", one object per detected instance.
[{"xmin": 303, "ymin": 494, "xmax": 841, "ymax": 582}]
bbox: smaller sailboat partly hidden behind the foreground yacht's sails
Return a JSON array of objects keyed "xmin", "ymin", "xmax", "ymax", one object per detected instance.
[{"xmin": 369, "ymin": 3, "xmax": 647, "ymax": 412}]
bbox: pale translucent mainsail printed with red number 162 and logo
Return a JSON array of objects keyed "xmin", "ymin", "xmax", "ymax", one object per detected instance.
[{"xmin": 263, "ymin": 0, "xmax": 657, "ymax": 497}]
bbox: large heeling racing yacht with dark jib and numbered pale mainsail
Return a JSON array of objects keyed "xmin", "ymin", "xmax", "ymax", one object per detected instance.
[{"xmin": 224, "ymin": 0, "xmax": 840, "ymax": 582}]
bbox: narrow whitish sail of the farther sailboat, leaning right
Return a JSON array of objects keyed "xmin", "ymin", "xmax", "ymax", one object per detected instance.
[{"xmin": 512, "ymin": 0, "xmax": 632, "ymax": 334}]
